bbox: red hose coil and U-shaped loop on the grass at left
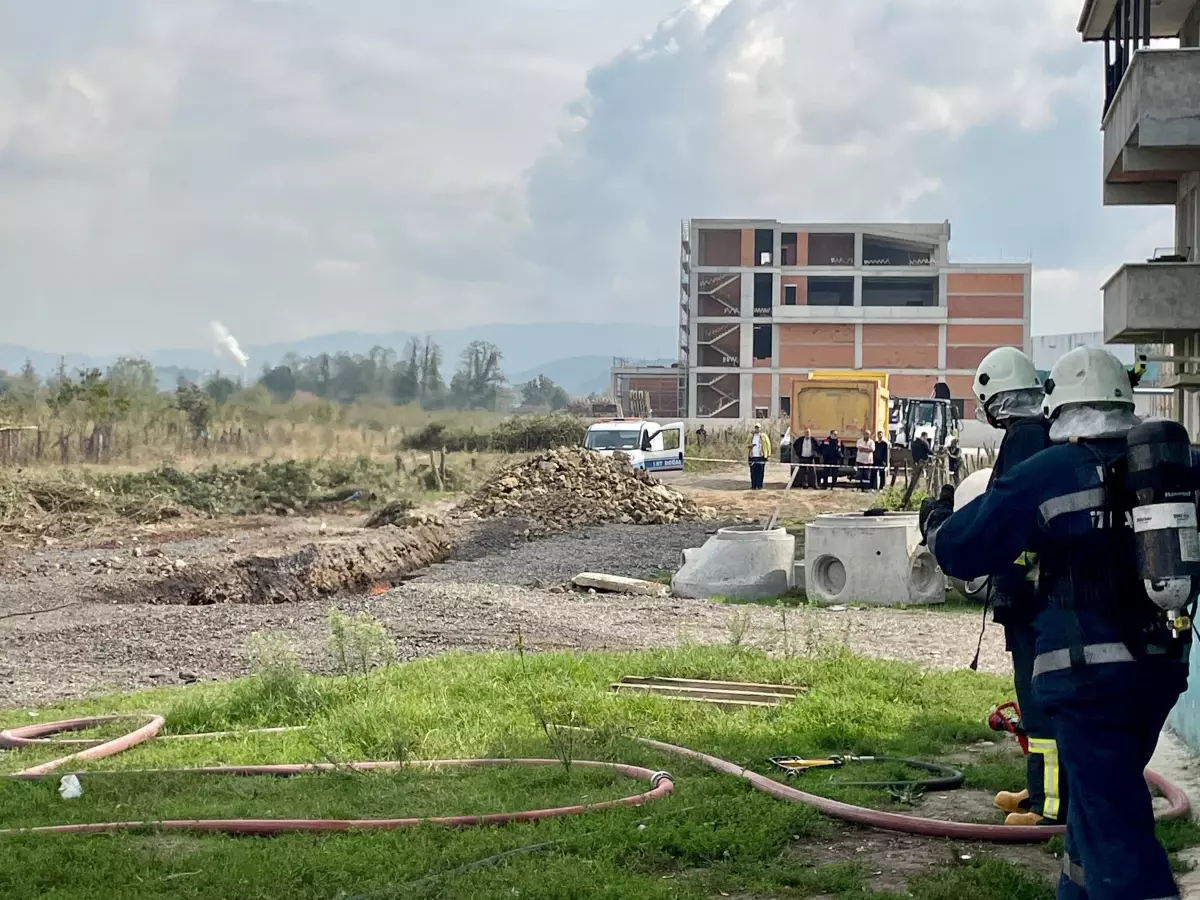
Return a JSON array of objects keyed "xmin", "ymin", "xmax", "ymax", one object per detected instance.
[{"xmin": 0, "ymin": 715, "xmax": 674, "ymax": 835}]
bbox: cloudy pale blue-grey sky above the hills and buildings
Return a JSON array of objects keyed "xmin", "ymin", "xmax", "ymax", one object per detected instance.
[{"xmin": 0, "ymin": 0, "xmax": 1172, "ymax": 354}]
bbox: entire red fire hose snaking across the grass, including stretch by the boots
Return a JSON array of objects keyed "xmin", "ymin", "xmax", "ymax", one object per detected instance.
[{"xmin": 0, "ymin": 715, "xmax": 1190, "ymax": 844}]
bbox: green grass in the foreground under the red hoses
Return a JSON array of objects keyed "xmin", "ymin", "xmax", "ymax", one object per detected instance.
[{"xmin": 0, "ymin": 647, "xmax": 1080, "ymax": 900}]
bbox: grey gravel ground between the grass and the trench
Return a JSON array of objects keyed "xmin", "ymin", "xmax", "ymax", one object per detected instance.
[{"xmin": 0, "ymin": 513, "xmax": 1007, "ymax": 708}]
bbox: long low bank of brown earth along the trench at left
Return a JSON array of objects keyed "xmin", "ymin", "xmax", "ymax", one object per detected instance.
[{"xmin": 101, "ymin": 517, "xmax": 450, "ymax": 606}]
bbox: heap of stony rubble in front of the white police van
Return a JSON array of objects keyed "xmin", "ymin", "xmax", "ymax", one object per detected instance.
[{"xmin": 460, "ymin": 448, "xmax": 709, "ymax": 533}]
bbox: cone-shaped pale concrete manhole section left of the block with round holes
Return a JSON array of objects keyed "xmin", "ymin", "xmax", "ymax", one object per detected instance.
[{"xmin": 671, "ymin": 526, "xmax": 796, "ymax": 600}]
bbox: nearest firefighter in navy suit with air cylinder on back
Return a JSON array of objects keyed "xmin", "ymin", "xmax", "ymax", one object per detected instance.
[{"xmin": 923, "ymin": 347, "xmax": 1185, "ymax": 900}]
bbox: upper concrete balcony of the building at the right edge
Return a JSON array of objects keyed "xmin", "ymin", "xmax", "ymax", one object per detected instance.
[{"xmin": 1103, "ymin": 48, "xmax": 1200, "ymax": 206}]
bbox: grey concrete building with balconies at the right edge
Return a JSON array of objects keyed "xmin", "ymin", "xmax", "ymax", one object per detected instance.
[{"xmin": 1079, "ymin": 0, "xmax": 1200, "ymax": 440}]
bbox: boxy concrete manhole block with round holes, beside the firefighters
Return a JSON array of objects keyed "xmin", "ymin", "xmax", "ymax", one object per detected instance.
[{"xmin": 804, "ymin": 512, "xmax": 946, "ymax": 606}]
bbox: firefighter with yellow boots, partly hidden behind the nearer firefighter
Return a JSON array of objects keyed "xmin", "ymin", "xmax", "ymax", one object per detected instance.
[{"xmin": 973, "ymin": 347, "xmax": 1067, "ymax": 826}]
